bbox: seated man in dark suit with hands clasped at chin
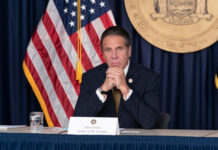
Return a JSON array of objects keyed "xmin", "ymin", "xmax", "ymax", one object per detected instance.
[{"xmin": 74, "ymin": 26, "xmax": 160, "ymax": 129}]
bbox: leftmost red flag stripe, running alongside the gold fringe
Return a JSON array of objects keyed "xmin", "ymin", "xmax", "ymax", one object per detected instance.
[{"xmin": 25, "ymin": 53, "xmax": 61, "ymax": 127}]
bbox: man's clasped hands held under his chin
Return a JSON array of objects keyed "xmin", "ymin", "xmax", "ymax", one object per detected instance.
[{"xmin": 101, "ymin": 67, "xmax": 130, "ymax": 98}]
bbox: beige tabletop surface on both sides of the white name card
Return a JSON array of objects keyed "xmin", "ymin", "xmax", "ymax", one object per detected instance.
[{"xmin": 0, "ymin": 127, "xmax": 218, "ymax": 137}]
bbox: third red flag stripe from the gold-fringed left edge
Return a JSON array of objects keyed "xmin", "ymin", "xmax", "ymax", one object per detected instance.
[{"xmin": 42, "ymin": 12, "xmax": 80, "ymax": 95}]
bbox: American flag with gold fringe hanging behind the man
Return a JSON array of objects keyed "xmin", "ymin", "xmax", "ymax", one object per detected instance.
[{"xmin": 23, "ymin": 0, "xmax": 115, "ymax": 127}]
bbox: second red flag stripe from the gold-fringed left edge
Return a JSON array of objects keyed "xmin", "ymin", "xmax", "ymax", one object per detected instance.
[{"xmin": 32, "ymin": 32, "xmax": 74, "ymax": 118}]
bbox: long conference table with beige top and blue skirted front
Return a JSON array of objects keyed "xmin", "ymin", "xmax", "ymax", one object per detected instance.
[{"xmin": 0, "ymin": 127, "xmax": 218, "ymax": 150}]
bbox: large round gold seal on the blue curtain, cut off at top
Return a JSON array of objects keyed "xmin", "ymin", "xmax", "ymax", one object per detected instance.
[{"xmin": 125, "ymin": 0, "xmax": 218, "ymax": 53}]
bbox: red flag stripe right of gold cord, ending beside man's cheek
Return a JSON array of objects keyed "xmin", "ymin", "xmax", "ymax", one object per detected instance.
[{"xmin": 85, "ymin": 23, "xmax": 105, "ymax": 63}]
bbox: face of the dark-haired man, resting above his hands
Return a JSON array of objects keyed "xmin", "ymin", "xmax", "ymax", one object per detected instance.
[{"xmin": 102, "ymin": 35, "xmax": 131, "ymax": 69}]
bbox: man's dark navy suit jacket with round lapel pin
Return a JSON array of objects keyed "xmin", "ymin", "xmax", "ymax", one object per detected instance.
[{"xmin": 74, "ymin": 62, "xmax": 160, "ymax": 129}]
